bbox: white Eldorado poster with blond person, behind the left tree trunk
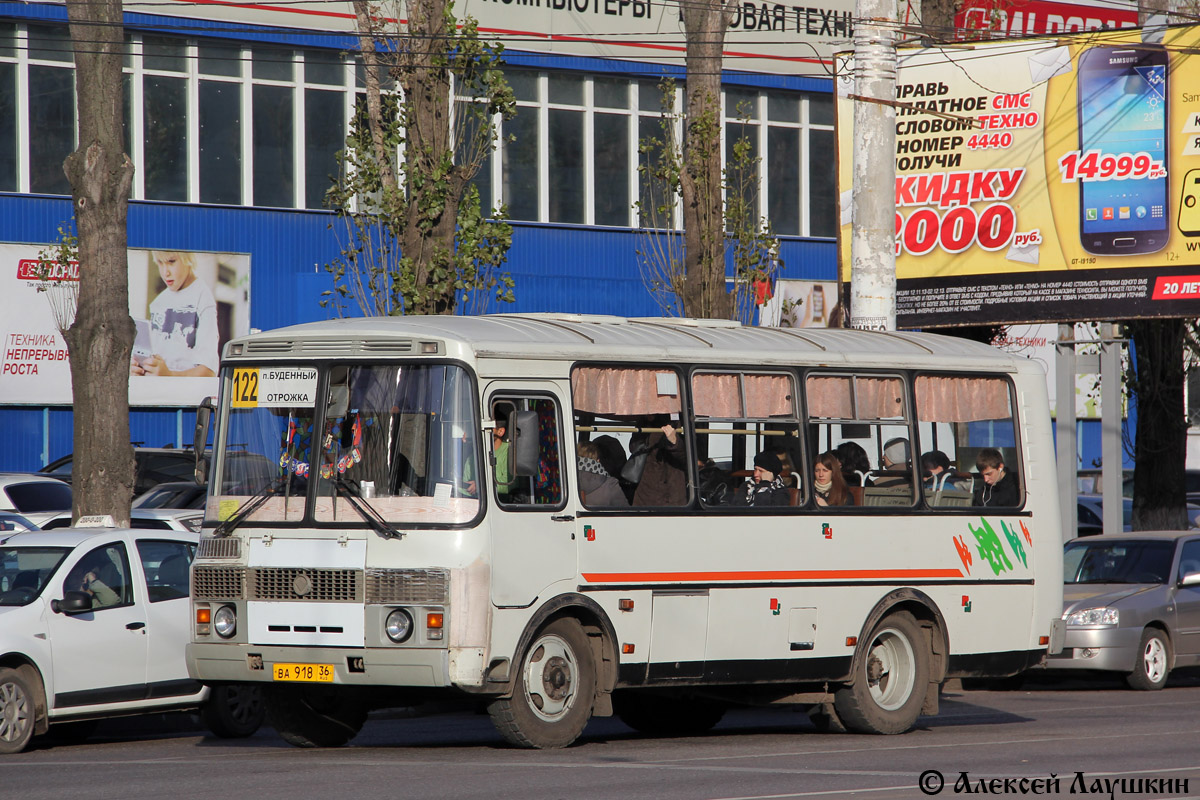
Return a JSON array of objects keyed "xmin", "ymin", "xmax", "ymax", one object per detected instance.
[{"xmin": 0, "ymin": 245, "xmax": 250, "ymax": 407}]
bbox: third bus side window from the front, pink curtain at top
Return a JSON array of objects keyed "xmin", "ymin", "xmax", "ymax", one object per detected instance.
[{"xmin": 804, "ymin": 373, "xmax": 916, "ymax": 507}]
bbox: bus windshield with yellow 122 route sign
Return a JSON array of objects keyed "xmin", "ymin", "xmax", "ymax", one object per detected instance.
[{"xmin": 208, "ymin": 362, "xmax": 481, "ymax": 525}]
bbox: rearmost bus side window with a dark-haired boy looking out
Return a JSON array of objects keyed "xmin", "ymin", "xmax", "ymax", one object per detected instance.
[{"xmin": 914, "ymin": 375, "xmax": 1024, "ymax": 509}]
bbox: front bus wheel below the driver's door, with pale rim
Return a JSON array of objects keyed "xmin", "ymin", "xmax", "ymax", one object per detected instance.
[{"xmin": 487, "ymin": 618, "xmax": 596, "ymax": 748}]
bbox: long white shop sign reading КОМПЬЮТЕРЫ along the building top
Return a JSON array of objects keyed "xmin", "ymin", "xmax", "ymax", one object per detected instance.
[{"xmin": 124, "ymin": 0, "xmax": 854, "ymax": 78}]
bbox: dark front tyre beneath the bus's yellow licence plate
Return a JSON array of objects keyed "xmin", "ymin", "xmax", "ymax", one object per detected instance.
[{"xmin": 263, "ymin": 686, "xmax": 367, "ymax": 747}]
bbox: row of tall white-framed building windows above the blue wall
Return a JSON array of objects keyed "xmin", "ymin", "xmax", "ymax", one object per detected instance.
[{"xmin": 0, "ymin": 23, "xmax": 836, "ymax": 236}]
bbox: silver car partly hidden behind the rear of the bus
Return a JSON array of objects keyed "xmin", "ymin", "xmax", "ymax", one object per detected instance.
[{"xmin": 1046, "ymin": 530, "xmax": 1200, "ymax": 690}]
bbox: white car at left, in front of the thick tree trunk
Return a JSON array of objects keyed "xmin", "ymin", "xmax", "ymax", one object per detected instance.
[{"xmin": 0, "ymin": 528, "xmax": 264, "ymax": 753}]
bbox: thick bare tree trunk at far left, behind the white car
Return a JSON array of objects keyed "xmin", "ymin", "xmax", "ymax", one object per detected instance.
[{"xmin": 64, "ymin": 0, "xmax": 133, "ymax": 525}]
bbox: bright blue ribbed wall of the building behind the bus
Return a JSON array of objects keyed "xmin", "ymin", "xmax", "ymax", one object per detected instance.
[{"xmin": 0, "ymin": 194, "xmax": 836, "ymax": 471}]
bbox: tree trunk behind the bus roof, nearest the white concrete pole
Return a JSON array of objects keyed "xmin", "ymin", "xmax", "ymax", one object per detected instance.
[{"xmin": 679, "ymin": 0, "xmax": 733, "ymax": 319}]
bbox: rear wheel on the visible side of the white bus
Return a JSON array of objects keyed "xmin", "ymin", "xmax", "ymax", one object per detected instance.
[{"xmin": 834, "ymin": 612, "xmax": 929, "ymax": 734}]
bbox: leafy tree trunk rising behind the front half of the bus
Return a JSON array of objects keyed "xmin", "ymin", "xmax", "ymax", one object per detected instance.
[{"xmin": 401, "ymin": 0, "xmax": 467, "ymax": 314}]
